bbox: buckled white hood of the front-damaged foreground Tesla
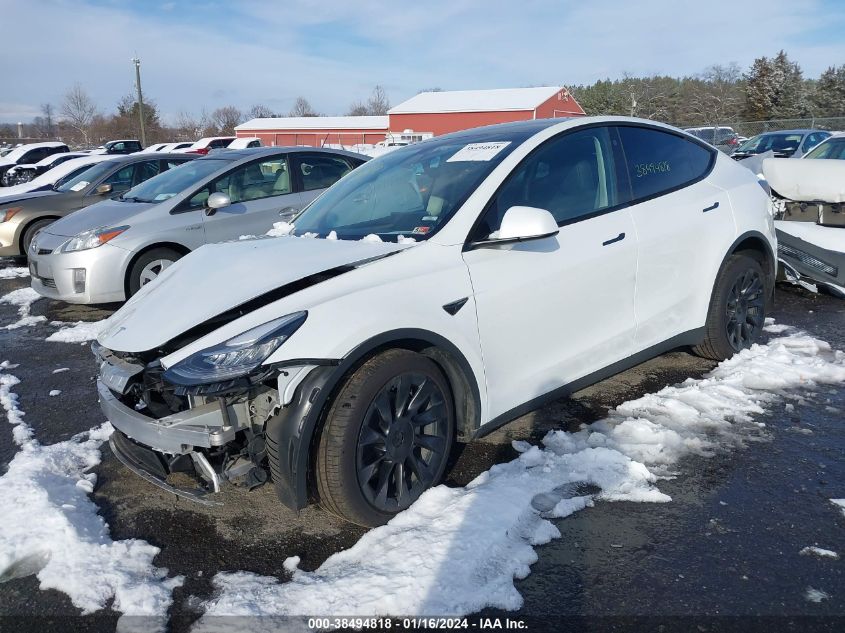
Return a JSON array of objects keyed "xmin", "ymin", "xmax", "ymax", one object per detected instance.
[{"xmin": 97, "ymin": 237, "xmax": 413, "ymax": 353}]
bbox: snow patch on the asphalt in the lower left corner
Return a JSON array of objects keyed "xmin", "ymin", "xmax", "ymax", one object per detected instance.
[{"xmin": 0, "ymin": 361, "xmax": 182, "ymax": 630}]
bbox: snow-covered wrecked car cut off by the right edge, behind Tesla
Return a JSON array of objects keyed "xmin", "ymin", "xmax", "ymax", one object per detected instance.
[{"xmin": 763, "ymin": 154, "xmax": 845, "ymax": 298}]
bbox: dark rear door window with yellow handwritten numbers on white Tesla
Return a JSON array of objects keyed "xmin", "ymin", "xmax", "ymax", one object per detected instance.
[{"xmin": 619, "ymin": 127, "xmax": 714, "ymax": 201}]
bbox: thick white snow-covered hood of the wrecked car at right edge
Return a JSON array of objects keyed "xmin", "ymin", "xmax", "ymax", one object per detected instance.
[{"xmin": 763, "ymin": 158, "xmax": 845, "ymax": 202}]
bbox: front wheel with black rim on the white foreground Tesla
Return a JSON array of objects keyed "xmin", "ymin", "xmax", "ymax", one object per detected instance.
[{"xmin": 316, "ymin": 349, "xmax": 455, "ymax": 527}]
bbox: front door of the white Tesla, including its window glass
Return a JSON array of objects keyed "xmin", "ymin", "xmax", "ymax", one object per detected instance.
[{"xmin": 464, "ymin": 127, "xmax": 637, "ymax": 418}]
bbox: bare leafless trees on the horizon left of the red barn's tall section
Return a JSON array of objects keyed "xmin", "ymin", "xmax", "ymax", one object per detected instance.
[{"xmin": 0, "ymin": 83, "xmax": 390, "ymax": 147}]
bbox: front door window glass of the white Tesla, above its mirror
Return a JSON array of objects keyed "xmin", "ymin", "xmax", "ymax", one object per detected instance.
[{"xmin": 472, "ymin": 127, "xmax": 628, "ymax": 240}]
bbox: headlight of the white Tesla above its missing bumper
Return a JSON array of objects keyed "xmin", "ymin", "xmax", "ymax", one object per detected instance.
[{"xmin": 164, "ymin": 312, "xmax": 308, "ymax": 385}]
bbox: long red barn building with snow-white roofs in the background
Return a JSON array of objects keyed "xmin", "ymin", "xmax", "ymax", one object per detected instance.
[{"xmin": 235, "ymin": 86, "xmax": 584, "ymax": 147}]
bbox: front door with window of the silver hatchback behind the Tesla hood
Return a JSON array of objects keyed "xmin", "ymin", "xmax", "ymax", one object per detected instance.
[{"xmin": 198, "ymin": 154, "xmax": 302, "ymax": 242}]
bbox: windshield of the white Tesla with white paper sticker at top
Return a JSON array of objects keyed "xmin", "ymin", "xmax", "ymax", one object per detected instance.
[{"xmin": 286, "ymin": 126, "xmax": 537, "ymax": 241}]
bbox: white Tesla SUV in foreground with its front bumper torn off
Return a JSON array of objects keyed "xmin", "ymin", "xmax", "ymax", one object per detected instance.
[{"xmin": 94, "ymin": 117, "xmax": 776, "ymax": 525}]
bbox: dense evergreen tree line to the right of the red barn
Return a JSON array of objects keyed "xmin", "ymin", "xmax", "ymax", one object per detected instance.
[{"xmin": 571, "ymin": 51, "xmax": 845, "ymax": 125}]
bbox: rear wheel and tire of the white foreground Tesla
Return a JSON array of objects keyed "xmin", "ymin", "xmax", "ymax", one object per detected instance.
[{"xmin": 693, "ymin": 253, "xmax": 768, "ymax": 360}]
